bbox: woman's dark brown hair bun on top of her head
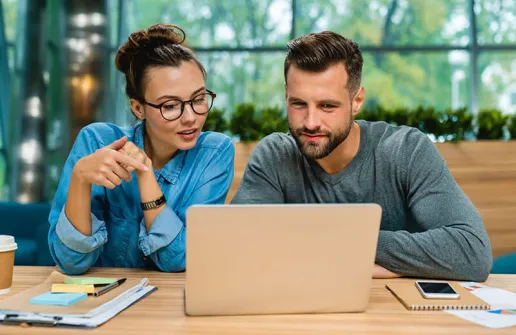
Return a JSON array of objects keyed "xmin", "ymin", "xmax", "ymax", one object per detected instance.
[{"xmin": 115, "ymin": 23, "xmax": 187, "ymax": 73}]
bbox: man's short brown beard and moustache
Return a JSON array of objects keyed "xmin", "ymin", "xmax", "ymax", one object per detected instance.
[{"xmin": 289, "ymin": 114, "xmax": 354, "ymax": 160}]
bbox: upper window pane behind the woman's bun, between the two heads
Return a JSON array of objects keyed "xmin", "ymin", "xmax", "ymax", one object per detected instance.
[{"xmin": 127, "ymin": 0, "xmax": 292, "ymax": 48}]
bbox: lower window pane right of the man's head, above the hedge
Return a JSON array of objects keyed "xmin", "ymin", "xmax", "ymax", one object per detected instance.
[{"xmin": 362, "ymin": 51, "xmax": 469, "ymax": 109}]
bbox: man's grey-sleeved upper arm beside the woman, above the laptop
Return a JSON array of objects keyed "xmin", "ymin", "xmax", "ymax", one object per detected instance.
[{"xmin": 231, "ymin": 134, "xmax": 285, "ymax": 204}]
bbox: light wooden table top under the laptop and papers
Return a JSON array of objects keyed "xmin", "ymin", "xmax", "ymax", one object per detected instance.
[{"xmin": 0, "ymin": 266, "xmax": 516, "ymax": 335}]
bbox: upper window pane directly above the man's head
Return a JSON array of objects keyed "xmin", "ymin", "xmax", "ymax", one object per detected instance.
[{"xmin": 296, "ymin": 0, "xmax": 469, "ymax": 46}]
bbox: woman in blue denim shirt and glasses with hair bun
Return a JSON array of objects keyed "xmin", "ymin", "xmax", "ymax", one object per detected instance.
[{"xmin": 48, "ymin": 24, "xmax": 234, "ymax": 274}]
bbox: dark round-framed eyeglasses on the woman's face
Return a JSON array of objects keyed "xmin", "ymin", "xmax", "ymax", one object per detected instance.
[{"xmin": 142, "ymin": 90, "xmax": 217, "ymax": 121}]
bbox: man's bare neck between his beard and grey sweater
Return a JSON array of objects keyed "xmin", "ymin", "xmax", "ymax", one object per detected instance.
[{"xmin": 317, "ymin": 122, "xmax": 360, "ymax": 175}]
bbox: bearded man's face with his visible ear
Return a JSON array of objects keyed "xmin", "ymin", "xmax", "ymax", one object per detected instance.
[{"xmin": 285, "ymin": 63, "xmax": 364, "ymax": 159}]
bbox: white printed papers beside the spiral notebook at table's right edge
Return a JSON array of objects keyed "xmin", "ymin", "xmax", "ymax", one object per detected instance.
[{"xmin": 445, "ymin": 282, "xmax": 516, "ymax": 328}]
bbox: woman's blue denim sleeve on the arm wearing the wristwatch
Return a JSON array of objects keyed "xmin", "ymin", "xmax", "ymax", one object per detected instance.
[{"xmin": 139, "ymin": 140, "xmax": 235, "ymax": 272}]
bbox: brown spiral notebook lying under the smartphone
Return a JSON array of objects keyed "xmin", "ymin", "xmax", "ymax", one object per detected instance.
[{"xmin": 386, "ymin": 280, "xmax": 490, "ymax": 311}]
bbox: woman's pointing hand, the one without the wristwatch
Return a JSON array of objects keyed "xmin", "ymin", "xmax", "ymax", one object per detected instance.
[{"xmin": 73, "ymin": 136, "xmax": 149, "ymax": 189}]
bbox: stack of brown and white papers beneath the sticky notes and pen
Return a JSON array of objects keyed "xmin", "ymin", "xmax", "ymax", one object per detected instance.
[{"xmin": 0, "ymin": 271, "xmax": 156, "ymax": 328}]
